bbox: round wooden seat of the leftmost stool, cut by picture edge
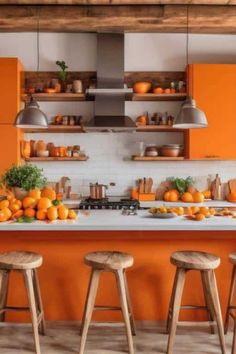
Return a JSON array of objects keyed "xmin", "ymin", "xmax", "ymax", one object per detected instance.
[{"xmin": 0, "ymin": 251, "xmax": 43, "ymax": 270}]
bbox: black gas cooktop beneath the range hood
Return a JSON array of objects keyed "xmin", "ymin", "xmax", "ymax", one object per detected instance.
[{"xmin": 79, "ymin": 198, "xmax": 139, "ymax": 210}]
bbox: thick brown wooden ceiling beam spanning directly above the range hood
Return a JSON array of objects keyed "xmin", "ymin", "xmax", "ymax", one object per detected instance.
[{"xmin": 0, "ymin": 4, "xmax": 236, "ymax": 34}]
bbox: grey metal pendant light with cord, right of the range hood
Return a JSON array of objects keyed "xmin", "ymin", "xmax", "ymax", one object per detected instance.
[{"xmin": 173, "ymin": 5, "xmax": 208, "ymax": 129}]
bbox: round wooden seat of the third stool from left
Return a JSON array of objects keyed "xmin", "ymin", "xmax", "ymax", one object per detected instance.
[{"xmin": 170, "ymin": 251, "xmax": 220, "ymax": 270}]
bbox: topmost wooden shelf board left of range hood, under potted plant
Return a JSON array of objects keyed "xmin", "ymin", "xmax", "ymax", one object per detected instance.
[{"xmin": 23, "ymin": 93, "xmax": 86, "ymax": 102}]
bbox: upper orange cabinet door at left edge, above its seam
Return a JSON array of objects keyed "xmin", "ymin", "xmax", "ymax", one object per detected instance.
[{"xmin": 0, "ymin": 58, "xmax": 23, "ymax": 124}]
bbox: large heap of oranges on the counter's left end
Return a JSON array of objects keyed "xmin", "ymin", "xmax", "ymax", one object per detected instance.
[{"xmin": 0, "ymin": 187, "xmax": 77, "ymax": 222}]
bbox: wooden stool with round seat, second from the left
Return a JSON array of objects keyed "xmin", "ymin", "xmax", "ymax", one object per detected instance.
[{"xmin": 79, "ymin": 251, "xmax": 135, "ymax": 354}]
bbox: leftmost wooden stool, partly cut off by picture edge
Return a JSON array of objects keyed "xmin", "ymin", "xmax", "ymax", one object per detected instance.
[{"xmin": 0, "ymin": 252, "xmax": 46, "ymax": 354}]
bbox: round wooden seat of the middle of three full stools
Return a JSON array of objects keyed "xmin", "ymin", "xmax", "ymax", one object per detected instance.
[{"xmin": 84, "ymin": 251, "xmax": 134, "ymax": 270}]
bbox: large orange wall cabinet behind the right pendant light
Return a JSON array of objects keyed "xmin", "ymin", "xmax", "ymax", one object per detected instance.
[{"xmin": 188, "ymin": 64, "xmax": 236, "ymax": 160}]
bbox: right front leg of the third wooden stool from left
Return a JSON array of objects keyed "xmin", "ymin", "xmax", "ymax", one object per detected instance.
[{"xmin": 204, "ymin": 270, "xmax": 226, "ymax": 354}]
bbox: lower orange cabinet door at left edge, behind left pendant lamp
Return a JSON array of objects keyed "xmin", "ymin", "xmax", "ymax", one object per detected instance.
[{"xmin": 0, "ymin": 124, "xmax": 22, "ymax": 176}]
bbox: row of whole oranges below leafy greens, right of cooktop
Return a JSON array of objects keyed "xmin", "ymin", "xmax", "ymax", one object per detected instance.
[{"xmin": 163, "ymin": 189, "xmax": 211, "ymax": 203}]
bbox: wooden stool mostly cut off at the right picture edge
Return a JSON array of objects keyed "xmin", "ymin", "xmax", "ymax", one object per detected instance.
[{"xmin": 225, "ymin": 253, "xmax": 236, "ymax": 354}]
